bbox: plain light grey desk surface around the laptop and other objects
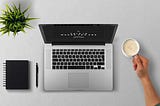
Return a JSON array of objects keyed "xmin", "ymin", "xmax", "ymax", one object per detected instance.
[{"xmin": 0, "ymin": 0, "xmax": 160, "ymax": 106}]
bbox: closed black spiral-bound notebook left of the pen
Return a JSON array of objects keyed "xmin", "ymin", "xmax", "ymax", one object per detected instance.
[{"xmin": 4, "ymin": 60, "xmax": 29, "ymax": 89}]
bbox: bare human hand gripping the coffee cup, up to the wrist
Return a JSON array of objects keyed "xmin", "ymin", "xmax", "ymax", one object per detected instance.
[{"xmin": 132, "ymin": 55, "xmax": 149, "ymax": 79}]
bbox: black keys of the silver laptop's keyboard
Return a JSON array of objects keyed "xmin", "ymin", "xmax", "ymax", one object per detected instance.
[{"xmin": 52, "ymin": 49, "xmax": 105, "ymax": 70}]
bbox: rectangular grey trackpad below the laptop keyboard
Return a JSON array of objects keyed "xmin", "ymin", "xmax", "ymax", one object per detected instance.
[{"xmin": 68, "ymin": 73, "xmax": 89, "ymax": 88}]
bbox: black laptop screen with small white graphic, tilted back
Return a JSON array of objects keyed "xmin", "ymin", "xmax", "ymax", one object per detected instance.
[{"xmin": 39, "ymin": 24, "xmax": 118, "ymax": 44}]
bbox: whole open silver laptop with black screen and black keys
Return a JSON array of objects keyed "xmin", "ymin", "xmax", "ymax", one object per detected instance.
[{"xmin": 39, "ymin": 24, "xmax": 118, "ymax": 91}]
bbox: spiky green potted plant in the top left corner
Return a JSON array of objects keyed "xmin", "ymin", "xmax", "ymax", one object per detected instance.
[{"xmin": 0, "ymin": 3, "xmax": 37, "ymax": 36}]
